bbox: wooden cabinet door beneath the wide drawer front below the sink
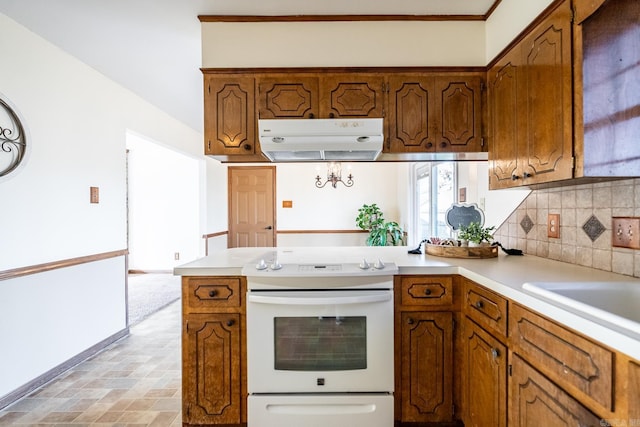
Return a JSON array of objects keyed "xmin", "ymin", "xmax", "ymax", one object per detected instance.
[{"xmin": 509, "ymin": 354, "xmax": 606, "ymax": 427}]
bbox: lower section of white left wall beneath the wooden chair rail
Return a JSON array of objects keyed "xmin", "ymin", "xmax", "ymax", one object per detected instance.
[{"xmin": 0, "ymin": 257, "xmax": 126, "ymax": 398}]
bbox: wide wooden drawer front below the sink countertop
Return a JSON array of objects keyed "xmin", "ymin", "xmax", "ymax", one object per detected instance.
[{"xmin": 509, "ymin": 304, "xmax": 614, "ymax": 411}]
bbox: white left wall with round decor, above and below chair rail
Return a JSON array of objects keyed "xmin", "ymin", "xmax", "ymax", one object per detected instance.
[{"xmin": 0, "ymin": 10, "xmax": 209, "ymax": 399}]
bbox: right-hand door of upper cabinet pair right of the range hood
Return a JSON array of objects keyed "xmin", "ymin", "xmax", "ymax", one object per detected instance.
[{"xmin": 435, "ymin": 76, "xmax": 482, "ymax": 152}]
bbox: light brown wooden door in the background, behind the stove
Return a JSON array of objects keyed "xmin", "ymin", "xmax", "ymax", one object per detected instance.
[{"xmin": 228, "ymin": 166, "xmax": 276, "ymax": 248}]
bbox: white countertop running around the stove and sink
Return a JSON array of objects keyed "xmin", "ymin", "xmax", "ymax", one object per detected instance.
[{"xmin": 174, "ymin": 246, "xmax": 640, "ymax": 360}]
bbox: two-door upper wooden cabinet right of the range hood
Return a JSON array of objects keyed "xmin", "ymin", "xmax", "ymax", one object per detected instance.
[{"xmin": 388, "ymin": 74, "xmax": 484, "ymax": 153}]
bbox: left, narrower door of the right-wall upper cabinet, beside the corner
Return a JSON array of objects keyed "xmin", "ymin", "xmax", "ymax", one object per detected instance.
[{"xmin": 487, "ymin": 48, "xmax": 523, "ymax": 190}]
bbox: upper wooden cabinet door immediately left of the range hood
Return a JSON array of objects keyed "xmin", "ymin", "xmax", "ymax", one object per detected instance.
[{"xmin": 204, "ymin": 74, "xmax": 256, "ymax": 155}]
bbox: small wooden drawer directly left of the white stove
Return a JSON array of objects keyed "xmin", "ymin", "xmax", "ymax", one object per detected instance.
[{"xmin": 183, "ymin": 277, "xmax": 241, "ymax": 311}]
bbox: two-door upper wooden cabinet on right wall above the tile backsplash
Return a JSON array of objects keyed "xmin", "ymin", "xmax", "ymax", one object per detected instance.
[{"xmin": 488, "ymin": 0, "xmax": 574, "ymax": 189}]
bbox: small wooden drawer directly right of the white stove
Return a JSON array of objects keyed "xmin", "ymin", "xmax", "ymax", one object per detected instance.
[{"xmin": 400, "ymin": 276, "xmax": 453, "ymax": 306}]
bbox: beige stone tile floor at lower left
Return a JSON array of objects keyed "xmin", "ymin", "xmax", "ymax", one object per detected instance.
[{"xmin": 0, "ymin": 301, "xmax": 182, "ymax": 427}]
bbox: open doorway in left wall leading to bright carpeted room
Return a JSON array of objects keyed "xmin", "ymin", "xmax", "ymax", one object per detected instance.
[{"xmin": 126, "ymin": 131, "xmax": 201, "ymax": 326}]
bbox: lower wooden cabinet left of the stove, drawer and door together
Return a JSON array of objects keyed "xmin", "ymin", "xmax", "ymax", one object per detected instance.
[{"xmin": 182, "ymin": 276, "xmax": 247, "ymax": 426}]
